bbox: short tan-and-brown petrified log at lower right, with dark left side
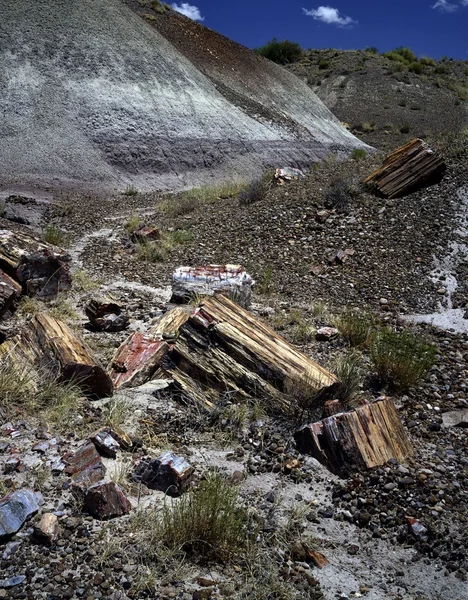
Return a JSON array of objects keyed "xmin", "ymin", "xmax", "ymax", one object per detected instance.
[{"xmin": 294, "ymin": 398, "xmax": 413, "ymax": 474}]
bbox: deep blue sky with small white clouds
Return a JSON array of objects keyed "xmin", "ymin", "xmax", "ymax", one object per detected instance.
[{"xmin": 172, "ymin": 0, "xmax": 468, "ymax": 60}]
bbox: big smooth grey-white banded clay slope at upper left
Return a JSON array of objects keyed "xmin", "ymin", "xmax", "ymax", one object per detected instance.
[{"xmin": 0, "ymin": 0, "xmax": 361, "ymax": 188}]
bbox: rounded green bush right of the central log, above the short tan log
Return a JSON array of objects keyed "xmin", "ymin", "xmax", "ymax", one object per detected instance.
[{"xmin": 370, "ymin": 327, "xmax": 436, "ymax": 391}]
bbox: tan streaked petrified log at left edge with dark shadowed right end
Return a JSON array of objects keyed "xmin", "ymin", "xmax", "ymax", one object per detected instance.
[{"xmin": 0, "ymin": 313, "xmax": 113, "ymax": 397}]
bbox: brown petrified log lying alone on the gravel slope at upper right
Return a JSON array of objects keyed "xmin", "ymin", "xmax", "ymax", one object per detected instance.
[{"xmin": 364, "ymin": 139, "xmax": 447, "ymax": 198}]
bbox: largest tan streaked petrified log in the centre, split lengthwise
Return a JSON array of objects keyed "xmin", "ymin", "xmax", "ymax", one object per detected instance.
[{"xmin": 159, "ymin": 294, "xmax": 338, "ymax": 412}]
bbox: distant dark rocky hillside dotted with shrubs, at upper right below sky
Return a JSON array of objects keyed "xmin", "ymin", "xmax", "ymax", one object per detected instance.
[{"xmin": 286, "ymin": 50, "xmax": 468, "ymax": 148}]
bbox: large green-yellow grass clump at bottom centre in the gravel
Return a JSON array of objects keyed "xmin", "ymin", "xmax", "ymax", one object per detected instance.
[{"xmin": 139, "ymin": 473, "xmax": 248, "ymax": 561}]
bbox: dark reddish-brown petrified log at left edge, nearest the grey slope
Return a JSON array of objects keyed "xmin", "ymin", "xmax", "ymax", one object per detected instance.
[{"xmin": 0, "ymin": 219, "xmax": 71, "ymax": 300}]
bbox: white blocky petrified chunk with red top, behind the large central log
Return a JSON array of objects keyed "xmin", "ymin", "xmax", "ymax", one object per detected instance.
[{"xmin": 171, "ymin": 265, "xmax": 254, "ymax": 308}]
